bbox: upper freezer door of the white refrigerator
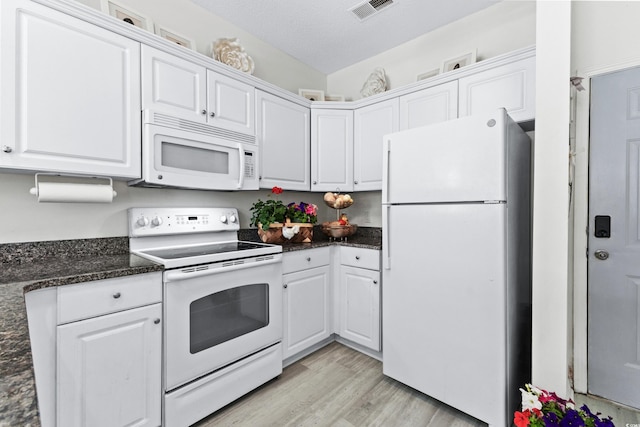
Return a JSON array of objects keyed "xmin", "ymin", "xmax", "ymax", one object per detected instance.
[{"xmin": 382, "ymin": 109, "xmax": 510, "ymax": 204}]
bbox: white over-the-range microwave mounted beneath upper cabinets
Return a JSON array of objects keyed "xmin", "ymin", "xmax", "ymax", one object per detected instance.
[{"xmin": 129, "ymin": 110, "xmax": 259, "ymax": 190}]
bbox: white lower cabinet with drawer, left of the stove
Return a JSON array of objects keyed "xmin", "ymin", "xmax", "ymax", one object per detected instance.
[{"xmin": 56, "ymin": 274, "xmax": 162, "ymax": 427}]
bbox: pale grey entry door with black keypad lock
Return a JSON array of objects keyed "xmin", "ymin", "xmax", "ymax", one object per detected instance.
[{"xmin": 588, "ymin": 68, "xmax": 640, "ymax": 408}]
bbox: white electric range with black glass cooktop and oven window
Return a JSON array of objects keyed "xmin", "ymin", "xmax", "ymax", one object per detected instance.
[{"xmin": 129, "ymin": 208, "xmax": 282, "ymax": 427}]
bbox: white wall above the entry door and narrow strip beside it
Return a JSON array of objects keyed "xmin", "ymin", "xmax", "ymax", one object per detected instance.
[{"xmin": 571, "ymin": 1, "xmax": 640, "ymax": 393}]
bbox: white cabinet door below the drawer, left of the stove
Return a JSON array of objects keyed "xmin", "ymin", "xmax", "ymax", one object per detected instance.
[{"xmin": 57, "ymin": 304, "xmax": 162, "ymax": 427}]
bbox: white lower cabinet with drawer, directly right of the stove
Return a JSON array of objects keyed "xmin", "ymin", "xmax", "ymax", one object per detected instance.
[{"xmin": 282, "ymin": 247, "xmax": 333, "ymax": 359}]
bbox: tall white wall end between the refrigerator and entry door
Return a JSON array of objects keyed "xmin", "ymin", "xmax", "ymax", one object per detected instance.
[{"xmin": 532, "ymin": 1, "xmax": 571, "ymax": 397}]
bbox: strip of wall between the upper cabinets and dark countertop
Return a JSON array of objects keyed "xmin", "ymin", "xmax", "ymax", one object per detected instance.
[{"xmin": 0, "ymin": 173, "xmax": 381, "ymax": 244}]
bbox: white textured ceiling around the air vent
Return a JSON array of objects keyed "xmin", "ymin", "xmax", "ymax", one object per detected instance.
[{"xmin": 192, "ymin": 0, "xmax": 500, "ymax": 74}]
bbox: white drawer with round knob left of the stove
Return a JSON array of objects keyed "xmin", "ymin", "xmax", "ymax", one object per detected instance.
[{"xmin": 58, "ymin": 272, "xmax": 162, "ymax": 325}]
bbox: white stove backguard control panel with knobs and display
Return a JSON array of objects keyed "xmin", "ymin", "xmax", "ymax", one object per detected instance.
[{"xmin": 128, "ymin": 208, "xmax": 240, "ymax": 237}]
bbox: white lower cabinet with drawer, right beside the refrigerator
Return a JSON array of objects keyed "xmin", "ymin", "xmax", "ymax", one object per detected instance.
[{"xmin": 338, "ymin": 247, "xmax": 381, "ymax": 351}]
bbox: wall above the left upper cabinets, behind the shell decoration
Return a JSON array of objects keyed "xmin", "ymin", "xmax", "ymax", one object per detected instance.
[{"xmin": 77, "ymin": 0, "xmax": 326, "ymax": 94}]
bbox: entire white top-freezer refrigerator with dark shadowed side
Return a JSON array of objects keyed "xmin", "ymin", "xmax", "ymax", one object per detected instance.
[{"xmin": 382, "ymin": 109, "xmax": 531, "ymax": 426}]
